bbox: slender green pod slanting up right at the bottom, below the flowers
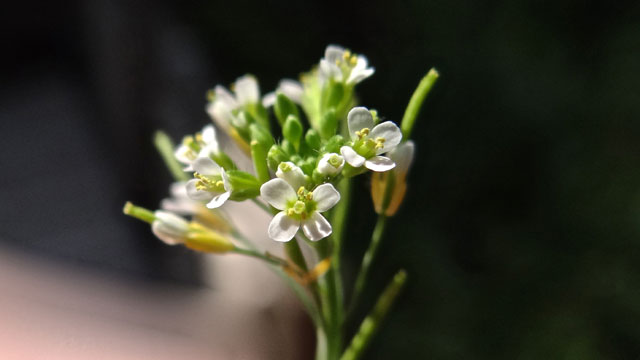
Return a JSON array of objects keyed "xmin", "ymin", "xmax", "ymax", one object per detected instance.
[{"xmin": 341, "ymin": 270, "xmax": 407, "ymax": 360}]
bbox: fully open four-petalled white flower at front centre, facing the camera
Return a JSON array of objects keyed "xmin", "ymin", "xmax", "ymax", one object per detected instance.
[{"xmin": 260, "ymin": 178, "xmax": 340, "ymax": 242}]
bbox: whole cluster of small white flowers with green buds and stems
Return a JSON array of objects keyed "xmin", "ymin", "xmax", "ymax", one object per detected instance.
[{"xmin": 124, "ymin": 45, "xmax": 437, "ymax": 359}]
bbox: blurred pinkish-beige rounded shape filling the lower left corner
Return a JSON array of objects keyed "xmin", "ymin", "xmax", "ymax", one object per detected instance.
[{"xmin": 0, "ymin": 202, "xmax": 313, "ymax": 360}]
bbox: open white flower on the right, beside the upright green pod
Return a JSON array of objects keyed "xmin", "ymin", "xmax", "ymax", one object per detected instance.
[{"xmin": 340, "ymin": 107, "xmax": 402, "ymax": 171}]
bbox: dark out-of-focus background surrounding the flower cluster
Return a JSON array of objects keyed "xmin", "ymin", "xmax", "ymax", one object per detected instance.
[{"xmin": 0, "ymin": 0, "xmax": 640, "ymax": 359}]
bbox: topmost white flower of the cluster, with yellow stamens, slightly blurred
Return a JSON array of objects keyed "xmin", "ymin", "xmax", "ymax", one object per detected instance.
[{"xmin": 320, "ymin": 45, "xmax": 374, "ymax": 85}]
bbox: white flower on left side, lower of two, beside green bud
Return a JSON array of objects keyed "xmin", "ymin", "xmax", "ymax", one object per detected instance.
[{"xmin": 187, "ymin": 157, "xmax": 232, "ymax": 209}]
